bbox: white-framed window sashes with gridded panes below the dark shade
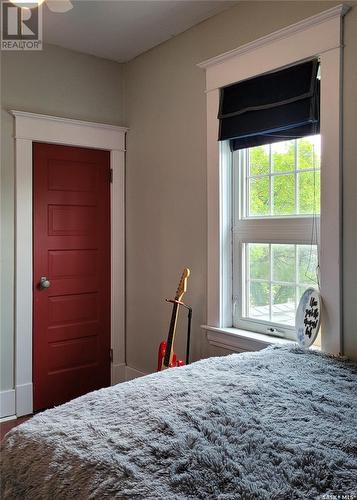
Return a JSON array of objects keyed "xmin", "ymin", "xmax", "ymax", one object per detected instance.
[{"xmin": 231, "ymin": 135, "xmax": 321, "ymax": 338}]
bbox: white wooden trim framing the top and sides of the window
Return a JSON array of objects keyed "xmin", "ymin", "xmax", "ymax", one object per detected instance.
[{"xmin": 198, "ymin": 5, "xmax": 349, "ymax": 354}]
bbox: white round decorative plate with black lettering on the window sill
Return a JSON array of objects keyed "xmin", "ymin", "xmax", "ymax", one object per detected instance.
[{"xmin": 295, "ymin": 288, "xmax": 321, "ymax": 347}]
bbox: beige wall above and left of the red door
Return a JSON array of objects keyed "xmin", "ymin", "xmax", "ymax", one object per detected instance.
[{"xmin": 0, "ymin": 45, "xmax": 124, "ymax": 390}]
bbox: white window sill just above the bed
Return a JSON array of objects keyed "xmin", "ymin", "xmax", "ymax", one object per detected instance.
[{"xmin": 201, "ymin": 325, "xmax": 295, "ymax": 352}]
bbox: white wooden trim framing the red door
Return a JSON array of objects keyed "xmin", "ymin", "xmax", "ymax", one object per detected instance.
[{"xmin": 10, "ymin": 110, "xmax": 128, "ymax": 416}]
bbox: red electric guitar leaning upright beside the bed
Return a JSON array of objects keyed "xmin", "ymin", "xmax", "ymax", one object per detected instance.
[{"xmin": 157, "ymin": 268, "xmax": 190, "ymax": 372}]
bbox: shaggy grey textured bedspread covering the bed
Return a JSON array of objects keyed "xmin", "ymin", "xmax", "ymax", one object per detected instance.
[{"xmin": 2, "ymin": 346, "xmax": 357, "ymax": 500}]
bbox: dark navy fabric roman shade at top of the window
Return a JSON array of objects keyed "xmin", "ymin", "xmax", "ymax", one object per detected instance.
[{"xmin": 218, "ymin": 59, "xmax": 320, "ymax": 150}]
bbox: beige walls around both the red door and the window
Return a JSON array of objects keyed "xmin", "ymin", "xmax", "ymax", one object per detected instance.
[{"xmin": 0, "ymin": 1, "xmax": 357, "ymax": 390}]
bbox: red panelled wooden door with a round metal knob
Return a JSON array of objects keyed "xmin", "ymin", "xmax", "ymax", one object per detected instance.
[{"xmin": 33, "ymin": 144, "xmax": 110, "ymax": 410}]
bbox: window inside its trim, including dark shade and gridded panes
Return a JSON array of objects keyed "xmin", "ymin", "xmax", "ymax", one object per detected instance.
[{"xmin": 218, "ymin": 58, "xmax": 321, "ymax": 338}]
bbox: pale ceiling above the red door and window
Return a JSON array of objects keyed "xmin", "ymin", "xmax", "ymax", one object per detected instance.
[{"xmin": 43, "ymin": 0, "xmax": 237, "ymax": 62}]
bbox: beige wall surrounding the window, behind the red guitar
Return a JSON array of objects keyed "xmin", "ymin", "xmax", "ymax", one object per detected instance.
[{"xmin": 126, "ymin": 1, "xmax": 357, "ymax": 372}]
